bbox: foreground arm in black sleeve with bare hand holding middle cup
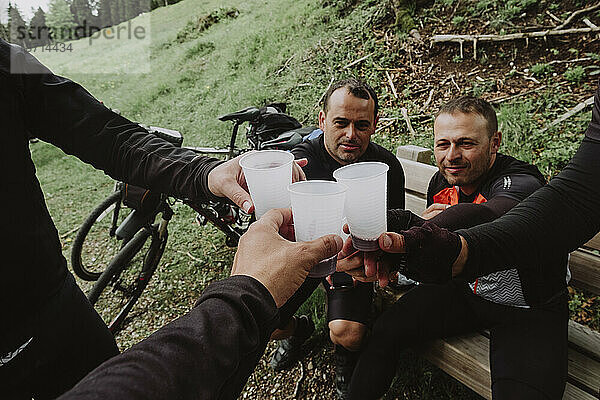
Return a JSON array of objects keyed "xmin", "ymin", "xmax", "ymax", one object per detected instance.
[{"xmin": 60, "ymin": 209, "xmax": 342, "ymax": 400}]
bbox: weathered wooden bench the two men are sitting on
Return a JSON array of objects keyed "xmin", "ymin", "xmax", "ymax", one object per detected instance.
[{"xmin": 390, "ymin": 146, "xmax": 600, "ymax": 400}]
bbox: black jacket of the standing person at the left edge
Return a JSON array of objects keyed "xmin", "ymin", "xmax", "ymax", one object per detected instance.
[{"xmin": 0, "ymin": 39, "xmax": 219, "ymax": 355}]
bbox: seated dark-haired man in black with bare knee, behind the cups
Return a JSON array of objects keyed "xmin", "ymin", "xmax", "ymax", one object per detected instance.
[{"xmin": 271, "ymin": 79, "xmax": 404, "ymax": 398}]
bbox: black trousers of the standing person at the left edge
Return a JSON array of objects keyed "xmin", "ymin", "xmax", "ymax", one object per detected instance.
[{"xmin": 0, "ymin": 273, "xmax": 119, "ymax": 400}]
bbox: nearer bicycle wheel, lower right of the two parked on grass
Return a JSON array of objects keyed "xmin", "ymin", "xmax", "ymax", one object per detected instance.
[{"xmin": 88, "ymin": 225, "xmax": 168, "ymax": 334}]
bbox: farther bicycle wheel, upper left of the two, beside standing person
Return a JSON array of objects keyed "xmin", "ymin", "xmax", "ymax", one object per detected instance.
[{"xmin": 71, "ymin": 191, "xmax": 129, "ymax": 281}]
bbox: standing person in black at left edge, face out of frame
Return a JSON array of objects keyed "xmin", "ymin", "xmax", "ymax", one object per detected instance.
[{"xmin": 0, "ymin": 39, "xmax": 302, "ymax": 399}]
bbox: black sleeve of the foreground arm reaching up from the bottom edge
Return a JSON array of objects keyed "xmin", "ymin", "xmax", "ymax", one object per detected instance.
[{"xmin": 60, "ymin": 276, "xmax": 279, "ymax": 400}]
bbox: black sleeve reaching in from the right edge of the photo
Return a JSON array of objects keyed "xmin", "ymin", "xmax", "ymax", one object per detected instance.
[{"xmin": 458, "ymin": 88, "xmax": 600, "ymax": 301}]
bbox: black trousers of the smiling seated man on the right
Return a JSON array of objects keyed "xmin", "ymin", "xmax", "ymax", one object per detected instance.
[{"xmin": 350, "ymin": 280, "xmax": 568, "ymax": 400}]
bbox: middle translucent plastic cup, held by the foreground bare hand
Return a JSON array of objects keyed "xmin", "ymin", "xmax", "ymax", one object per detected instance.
[{"xmin": 289, "ymin": 180, "xmax": 346, "ymax": 278}]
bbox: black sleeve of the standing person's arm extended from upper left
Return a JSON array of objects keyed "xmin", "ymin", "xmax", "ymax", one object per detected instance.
[{"xmin": 5, "ymin": 39, "xmax": 219, "ymax": 200}]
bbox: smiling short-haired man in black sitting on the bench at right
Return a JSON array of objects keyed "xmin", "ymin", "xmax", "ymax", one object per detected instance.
[{"xmin": 340, "ymin": 97, "xmax": 568, "ymax": 399}]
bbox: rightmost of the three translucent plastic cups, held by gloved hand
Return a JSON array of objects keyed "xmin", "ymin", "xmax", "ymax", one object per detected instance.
[{"xmin": 333, "ymin": 162, "xmax": 389, "ymax": 251}]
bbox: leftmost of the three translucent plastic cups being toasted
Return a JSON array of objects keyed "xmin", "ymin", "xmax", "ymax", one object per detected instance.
[{"xmin": 240, "ymin": 150, "xmax": 294, "ymax": 219}]
